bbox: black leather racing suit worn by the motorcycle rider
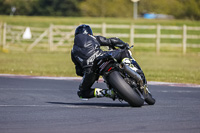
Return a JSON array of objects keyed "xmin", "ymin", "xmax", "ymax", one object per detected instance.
[{"xmin": 71, "ymin": 34, "xmax": 131, "ymax": 98}]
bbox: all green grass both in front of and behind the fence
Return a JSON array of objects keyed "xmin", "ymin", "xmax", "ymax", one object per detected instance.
[{"xmin": 0, "ymin": 16, "xmax": 200, "ymax": 84}]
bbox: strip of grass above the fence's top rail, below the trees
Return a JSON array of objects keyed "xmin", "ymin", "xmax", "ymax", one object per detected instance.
[{"xmin": 0, "ymin": 15, "xmax": 200, "ymax": 27}]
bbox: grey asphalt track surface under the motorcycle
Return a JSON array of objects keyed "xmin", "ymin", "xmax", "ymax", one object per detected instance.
[{"xmin": 0, "ymin": 76, "xmax": 200, "ymax": 133}]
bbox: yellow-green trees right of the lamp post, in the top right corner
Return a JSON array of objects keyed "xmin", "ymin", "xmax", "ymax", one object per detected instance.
[{"xmin": 139, "ymin": 0, "xmax": 200, "ymax": 20}]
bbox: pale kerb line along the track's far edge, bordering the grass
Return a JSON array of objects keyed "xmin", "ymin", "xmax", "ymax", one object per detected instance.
[{"xmin": 0, "ymin": 74, "xmax": 200, "ymax": 88}]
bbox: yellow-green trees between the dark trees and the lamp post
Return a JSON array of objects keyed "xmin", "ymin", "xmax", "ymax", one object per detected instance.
[{"xmin": 80, "ymin": 0, "xmax": 132, "ymax": 17}]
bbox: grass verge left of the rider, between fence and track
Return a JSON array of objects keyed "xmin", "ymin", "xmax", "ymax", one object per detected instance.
[{"xmin": 0, "ymin": 52, "xmax": 75, "ymax": 76}]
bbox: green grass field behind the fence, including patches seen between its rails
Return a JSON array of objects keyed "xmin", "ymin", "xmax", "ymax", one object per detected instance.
[{"xmin": 0, "ymin": 16, "xmax": 200, "ymax": 53}]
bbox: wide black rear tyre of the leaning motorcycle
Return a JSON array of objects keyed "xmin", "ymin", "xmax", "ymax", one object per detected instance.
[{"xmin": 107, "ymin": 71, "xmax": 144, "ymax": 107}]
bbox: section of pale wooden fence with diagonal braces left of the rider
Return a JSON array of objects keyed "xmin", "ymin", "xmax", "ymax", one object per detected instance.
[{"xmin": 0, "ymin": 23, "xmax": 75, "ymax": 51}]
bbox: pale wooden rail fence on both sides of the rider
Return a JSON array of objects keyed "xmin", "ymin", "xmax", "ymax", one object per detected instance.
[{"xmin": 0, "ymin": 23, "xmax": 200, "ymax": 54}]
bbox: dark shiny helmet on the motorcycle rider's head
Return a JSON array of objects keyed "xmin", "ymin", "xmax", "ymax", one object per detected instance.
[{"xmin": 75, "ymin": 24, "xmax": 93, "ymax": 36}]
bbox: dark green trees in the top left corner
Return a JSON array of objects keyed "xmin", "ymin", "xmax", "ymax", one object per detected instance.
[{"xmin": 0, "ymin": 0, "xmax": 82, "ymax": 16}]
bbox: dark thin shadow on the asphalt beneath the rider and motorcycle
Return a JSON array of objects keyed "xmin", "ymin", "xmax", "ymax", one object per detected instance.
[{"xmin": 47, "ymin": 102, "xmax": 130, "ymax": 108}]
